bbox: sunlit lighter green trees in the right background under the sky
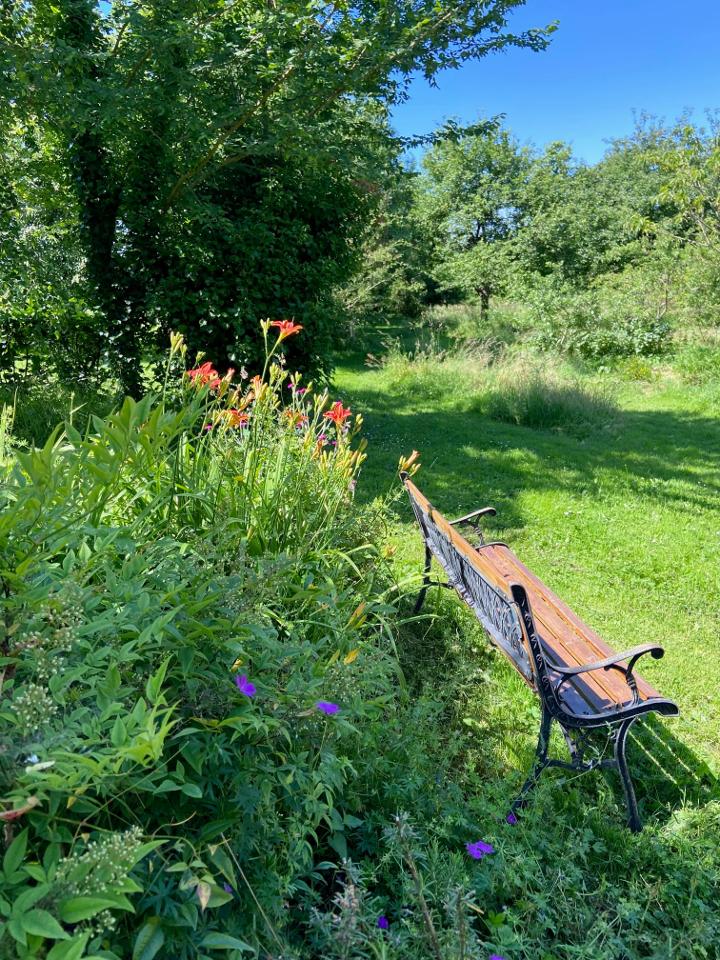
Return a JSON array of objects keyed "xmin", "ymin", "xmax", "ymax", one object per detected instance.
[{"xmin": 345, "ymin": 118, "xmax": 720, "ymax": 359}]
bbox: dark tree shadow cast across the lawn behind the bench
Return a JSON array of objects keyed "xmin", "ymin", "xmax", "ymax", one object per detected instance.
[{"xmin": 344, "ymin": 382, "xmax": 720, "ymax": 529}]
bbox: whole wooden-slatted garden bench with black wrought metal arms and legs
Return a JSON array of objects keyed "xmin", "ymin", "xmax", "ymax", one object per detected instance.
[{"xmin": 401, "ymin": 473, "xmax": 678, "ymax": 832}]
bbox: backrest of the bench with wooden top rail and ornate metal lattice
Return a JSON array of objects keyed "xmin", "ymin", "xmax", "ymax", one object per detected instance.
[{"xmin": 403, "ymin": 477, "xmax": 536, "ymax": 688}]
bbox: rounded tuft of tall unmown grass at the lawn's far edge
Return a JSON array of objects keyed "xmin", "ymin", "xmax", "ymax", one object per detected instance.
[{"xmin": 475, "ymin": 361, "xmax": 617, "ymax": 436}]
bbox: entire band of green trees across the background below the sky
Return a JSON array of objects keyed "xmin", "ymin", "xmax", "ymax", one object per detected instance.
[{"xmin": 0, "ymin": 0, "xmax": 720, "ymax": 402}]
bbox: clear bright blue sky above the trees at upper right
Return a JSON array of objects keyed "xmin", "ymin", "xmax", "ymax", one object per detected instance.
[{"xmin": 393, "ymin": 0, "xmax": 720, "ymax": 163}]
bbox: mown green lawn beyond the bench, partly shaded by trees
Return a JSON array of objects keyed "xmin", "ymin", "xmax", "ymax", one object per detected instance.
[{"xmin": 335, "ymin": 363, "xmax": 720, "ymax": 776}]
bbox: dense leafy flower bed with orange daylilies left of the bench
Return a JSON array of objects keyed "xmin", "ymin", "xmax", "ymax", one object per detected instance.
[{"xmin": 0, "ymin": 328, "xmax": 400, "ymax": 960}]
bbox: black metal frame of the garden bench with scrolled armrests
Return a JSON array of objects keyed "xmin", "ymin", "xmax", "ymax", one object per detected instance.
[{"xmin": 400, "ymin": 473, "xmax": 679, "ymax": 833}]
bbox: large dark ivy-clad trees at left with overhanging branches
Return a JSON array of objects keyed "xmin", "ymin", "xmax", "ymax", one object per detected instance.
[{"xmin": 0, "ymin": 0, "xmax": 550, "ymax": 392}]
